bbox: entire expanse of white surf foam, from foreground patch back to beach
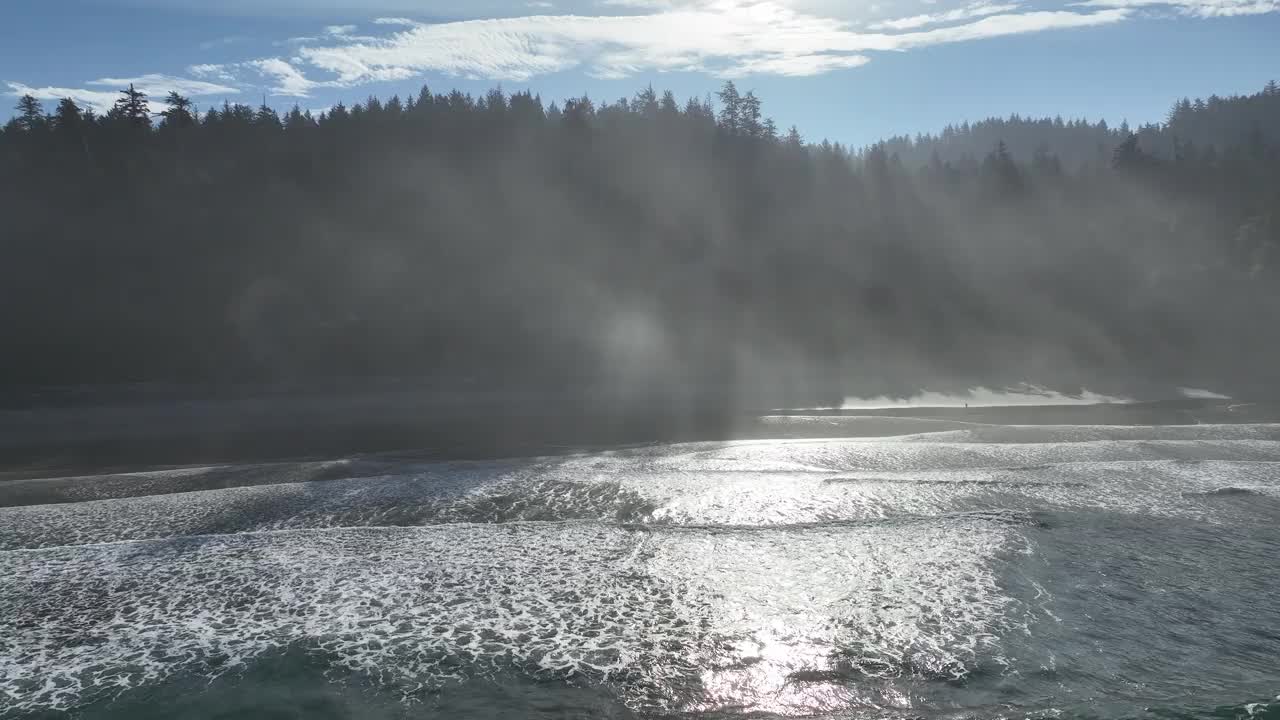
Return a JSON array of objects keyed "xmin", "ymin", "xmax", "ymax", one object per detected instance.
[{"xmin": 10, "ymin": 425, "xmax": 1280, "ymax": 715}]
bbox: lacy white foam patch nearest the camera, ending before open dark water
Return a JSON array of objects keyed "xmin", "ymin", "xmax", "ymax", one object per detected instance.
[{"xmin": 0, "ymin": 519, "xmax": 1021, "ymax": 714}]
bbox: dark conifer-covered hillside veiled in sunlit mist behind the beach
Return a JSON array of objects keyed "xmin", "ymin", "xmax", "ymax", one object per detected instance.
[{"xmin": 0, "ymin": 83, "xmax": 1280, "ymax": 404}]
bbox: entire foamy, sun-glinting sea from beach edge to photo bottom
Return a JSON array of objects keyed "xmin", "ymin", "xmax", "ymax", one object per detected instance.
[{"xmin": 0, "ymin": 418, "xmax": 1280, "ymax": 717}]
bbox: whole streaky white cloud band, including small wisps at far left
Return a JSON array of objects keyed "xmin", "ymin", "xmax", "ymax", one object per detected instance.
[{"xmin": 9, "ymin": 0, "xmax": 1146, "ymax": 110}]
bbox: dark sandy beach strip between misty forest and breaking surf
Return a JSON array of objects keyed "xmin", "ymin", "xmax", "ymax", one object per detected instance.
[{"xmin": 0, "ymin": 391, "xmax": 1280, "ymax": 482}]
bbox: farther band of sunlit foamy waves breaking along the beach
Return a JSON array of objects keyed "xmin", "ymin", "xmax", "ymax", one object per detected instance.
[{"xmin": 0, "ymin": 428, "xmax": 1280, "ymax": 550}]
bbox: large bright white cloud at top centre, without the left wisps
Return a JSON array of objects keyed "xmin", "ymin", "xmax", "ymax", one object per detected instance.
[{"xmin": 285, "ymin": 0, "xmax": 1126, "ymax": 87}]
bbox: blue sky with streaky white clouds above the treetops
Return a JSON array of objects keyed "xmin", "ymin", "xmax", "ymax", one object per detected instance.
[{"xmin": 0, "ymin": 0, "xmax": 1280, "ymax": 145}]
